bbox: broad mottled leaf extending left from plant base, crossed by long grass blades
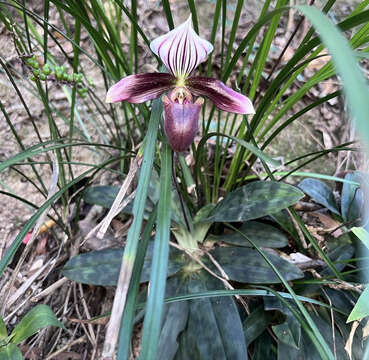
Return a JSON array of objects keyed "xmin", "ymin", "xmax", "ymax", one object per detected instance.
[{"xmin": 63, "ymin": 241, "xmax": 182, "ymax": 286}]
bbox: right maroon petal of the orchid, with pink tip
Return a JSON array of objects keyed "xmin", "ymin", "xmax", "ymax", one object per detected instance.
[{"xmin": 186, "ymin": 76, "xmax": 255, "ymax": 114}]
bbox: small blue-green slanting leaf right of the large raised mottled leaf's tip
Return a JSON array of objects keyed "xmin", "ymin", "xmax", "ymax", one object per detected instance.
[{"xmin": 299, "ymin": 179, "xmax": 340, "ymax": 215}]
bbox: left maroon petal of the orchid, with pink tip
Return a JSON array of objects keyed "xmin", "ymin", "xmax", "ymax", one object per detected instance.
[{"xmin": 106, "ymin": 73, "xmax": 175, "ymax": 104}]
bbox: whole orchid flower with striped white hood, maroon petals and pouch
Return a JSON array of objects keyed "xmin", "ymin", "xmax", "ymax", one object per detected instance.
[{"xmin": 106, "ymin": 16, "xmax": 255, "ymax": 152}]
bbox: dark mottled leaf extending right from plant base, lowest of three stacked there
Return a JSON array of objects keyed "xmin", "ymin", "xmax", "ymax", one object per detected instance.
[{"xmin": 207, "ymin": 247, "xmax": 304, "ymax": 284}]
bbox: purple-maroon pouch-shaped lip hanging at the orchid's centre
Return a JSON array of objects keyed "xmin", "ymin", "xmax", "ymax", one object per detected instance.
[{"xmin": 162, "ymin": 96, "xmax": 203, "ymax": 152}]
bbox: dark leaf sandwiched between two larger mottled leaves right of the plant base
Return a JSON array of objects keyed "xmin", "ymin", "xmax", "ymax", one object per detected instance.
[{"xmin": 208, "ymin": 221, "xmax": 288, "ymax": 248}]
